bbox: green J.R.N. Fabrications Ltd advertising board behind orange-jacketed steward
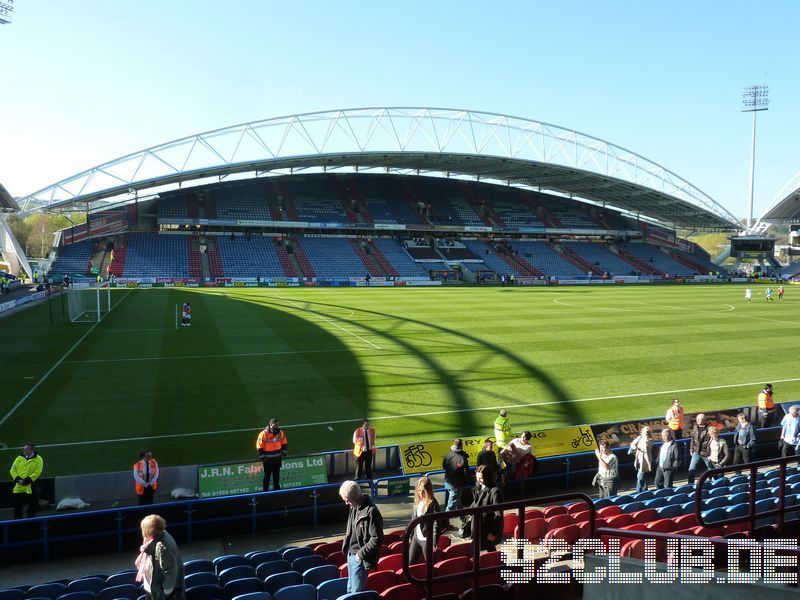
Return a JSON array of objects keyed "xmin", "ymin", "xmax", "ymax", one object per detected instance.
[{"xmin": 197, "ymin": 456, "xmax": 328, "ymax": 498}]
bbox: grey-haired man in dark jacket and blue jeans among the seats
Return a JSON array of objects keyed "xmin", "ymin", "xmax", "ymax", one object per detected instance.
[{"xmin": 339, "ymin": 481, "xmax": 383, "ymax": 594}]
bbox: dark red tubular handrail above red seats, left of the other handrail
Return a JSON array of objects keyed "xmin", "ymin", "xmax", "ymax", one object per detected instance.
[{"xmin": 402, "ymin": 492, "xmax": 596, "ymax": 598}]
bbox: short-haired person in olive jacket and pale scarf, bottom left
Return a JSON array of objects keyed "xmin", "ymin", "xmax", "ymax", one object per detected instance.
[{"xmin": 136, "ymin": 515, "xmax": 185, "ymax": 600}]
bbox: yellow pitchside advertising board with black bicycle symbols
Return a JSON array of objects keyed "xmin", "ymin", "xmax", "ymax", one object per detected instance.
[{"xmin": 400, "ymin": 425, "xmax": 597, "ymax": 475}]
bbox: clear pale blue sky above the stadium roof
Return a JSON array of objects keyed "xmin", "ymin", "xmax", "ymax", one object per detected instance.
[{"xmin": 0, "ymin": 0, "xmax": 800, "ymax": 221}]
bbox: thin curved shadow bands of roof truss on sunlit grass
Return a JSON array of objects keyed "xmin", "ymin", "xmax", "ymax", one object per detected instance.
[{"xmin": 262, "ymin": 298, "xmax": 585, "ymax": 435}]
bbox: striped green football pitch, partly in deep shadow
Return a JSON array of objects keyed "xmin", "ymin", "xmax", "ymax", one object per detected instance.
[{"xmin": 0, "ymin": 285, "xmax": 800, "ymax": 476}]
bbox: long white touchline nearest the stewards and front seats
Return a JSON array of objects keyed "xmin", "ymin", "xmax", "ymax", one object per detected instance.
[{"xmin": 20, "ymin": 377, "xmax": 800, "ymax": 448}]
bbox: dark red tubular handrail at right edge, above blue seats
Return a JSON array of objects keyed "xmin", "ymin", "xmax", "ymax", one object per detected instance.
[{"xmin": 694, "ymin": 456, "xmax": 800, "ymax": 537}]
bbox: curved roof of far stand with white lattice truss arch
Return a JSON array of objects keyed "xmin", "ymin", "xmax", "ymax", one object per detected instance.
[{"xmin": 19, "ymin": 107, "xmax": 736, "ymax": 229}]
